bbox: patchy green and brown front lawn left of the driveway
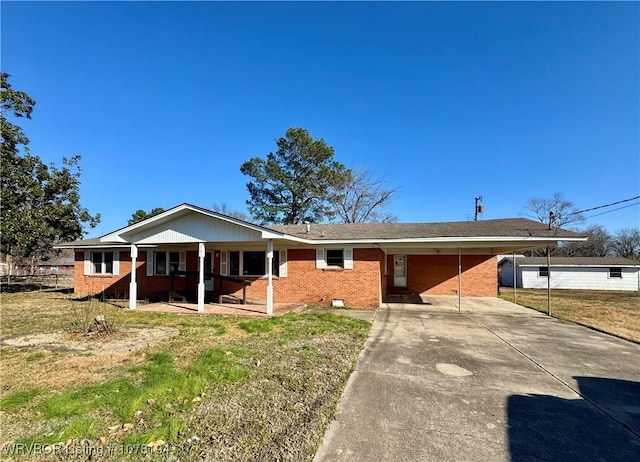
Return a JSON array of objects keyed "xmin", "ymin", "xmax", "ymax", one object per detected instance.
[{"xmin": 0, "ymin": 292, "xmax": 370, "ymax": 461}]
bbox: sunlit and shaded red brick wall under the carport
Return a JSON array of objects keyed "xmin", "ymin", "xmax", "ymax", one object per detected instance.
[{"xmin": 388, "ymin": 255, "xmax": 498, "ymax": 297}]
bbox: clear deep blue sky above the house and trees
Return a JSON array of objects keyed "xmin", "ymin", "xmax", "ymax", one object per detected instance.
[{"xmin": 0, "ymin": 1, "xmax": 640, "ymax": 236}]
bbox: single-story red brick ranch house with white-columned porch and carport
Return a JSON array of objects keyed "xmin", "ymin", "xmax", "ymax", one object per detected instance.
[{"xmin": 61, "ymin": 204, "xmax": 586, "ymax": 314}]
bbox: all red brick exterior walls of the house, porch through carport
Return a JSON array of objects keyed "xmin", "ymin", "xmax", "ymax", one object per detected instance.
[{"xmin": 74, "ymin": 249, "xmax": 498, "ymax": 307}]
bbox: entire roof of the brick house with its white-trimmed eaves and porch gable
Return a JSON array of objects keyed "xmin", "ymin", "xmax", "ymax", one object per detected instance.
[{"xmin": 58, "ymin": 203, "xmax": 586, "ymax": 253}]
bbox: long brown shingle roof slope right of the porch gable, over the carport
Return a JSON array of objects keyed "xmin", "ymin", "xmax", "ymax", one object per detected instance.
[{"xmin": 267, "ymin": 218, "xmax": 580, "ymax": 240}]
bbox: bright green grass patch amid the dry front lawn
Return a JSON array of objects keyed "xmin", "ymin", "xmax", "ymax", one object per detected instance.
[{"xmin": 28, "ymin": 347, "xmax": 248, "ymax": 443}]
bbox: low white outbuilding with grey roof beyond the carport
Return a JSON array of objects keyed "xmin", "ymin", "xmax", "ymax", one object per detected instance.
[{"xmin": 499, "ymin": 256, "xmax": 640, "ymax": 291}]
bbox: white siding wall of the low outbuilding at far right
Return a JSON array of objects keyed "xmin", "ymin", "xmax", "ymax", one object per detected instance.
[{"xmin": 524, "ymin": 264, "xmax": 640, "ymax": 290}]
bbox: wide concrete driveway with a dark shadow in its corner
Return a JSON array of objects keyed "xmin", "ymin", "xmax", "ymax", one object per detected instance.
[{"xmin": 314, "ymin": 297, "xmax": 640, "ymax": 462}]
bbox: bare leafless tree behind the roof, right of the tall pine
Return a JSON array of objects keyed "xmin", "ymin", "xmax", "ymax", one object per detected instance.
[{"xmin": 332, "ymin": 168, "xmax": 398, "ymax": 223}]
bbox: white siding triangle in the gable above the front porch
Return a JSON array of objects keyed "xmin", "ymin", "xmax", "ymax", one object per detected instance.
[{"xmin": 131, "ymin": 214, "xmax": 263, "ymax": 244}]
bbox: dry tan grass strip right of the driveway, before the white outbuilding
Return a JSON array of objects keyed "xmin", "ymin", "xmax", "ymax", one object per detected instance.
[{"xmin": 500, "ymin": 287, "xmax": 640, "ymax": 342}]
